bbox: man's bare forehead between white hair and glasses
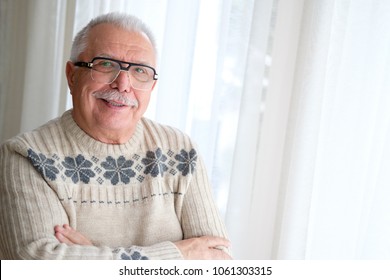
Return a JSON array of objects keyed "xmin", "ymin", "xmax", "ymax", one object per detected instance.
[{"xmin": 86, "ymin": 24, "xmax": 155, "ymax": 64}]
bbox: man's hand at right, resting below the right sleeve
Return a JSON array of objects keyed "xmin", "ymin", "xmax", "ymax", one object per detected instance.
[{"xmin": 174, "ymin": 236, "xmax": 232, "ymax": 260}]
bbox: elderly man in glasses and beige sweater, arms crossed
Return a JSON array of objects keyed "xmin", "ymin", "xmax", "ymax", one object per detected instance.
[{"xmin": 0, "ymin": 13, "xmax": 230, "ymax": 259}]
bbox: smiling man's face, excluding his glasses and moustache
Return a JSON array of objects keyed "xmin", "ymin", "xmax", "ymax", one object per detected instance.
[{"xmin": 66, "ymin": 24, "xmax": 156, "ymax": 144}]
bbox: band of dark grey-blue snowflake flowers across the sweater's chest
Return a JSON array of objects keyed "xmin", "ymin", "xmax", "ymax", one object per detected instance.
[{"xmin": 27, "ymin": 148, "xmax": 198, "ymax": 185}]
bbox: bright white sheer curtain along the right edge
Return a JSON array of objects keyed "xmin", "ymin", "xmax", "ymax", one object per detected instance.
[{"xmin": 275, "ymin": 0, "xmax": 390, "ymax": 259}]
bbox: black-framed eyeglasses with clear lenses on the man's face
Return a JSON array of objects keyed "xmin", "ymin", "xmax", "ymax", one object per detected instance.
[{"xmin": 74, "ymin": 57, "xmax": 158, "ymax": 90}]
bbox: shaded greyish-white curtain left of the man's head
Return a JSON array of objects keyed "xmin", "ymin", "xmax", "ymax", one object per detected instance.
[{"xmin": 0, "ymin": 0, "xmax": 72, "ymax": 141}]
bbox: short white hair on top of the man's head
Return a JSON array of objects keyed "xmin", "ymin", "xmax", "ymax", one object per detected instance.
[{"xmin": 70, "ymin": 12, "xmax": 157, "ymax": 62}]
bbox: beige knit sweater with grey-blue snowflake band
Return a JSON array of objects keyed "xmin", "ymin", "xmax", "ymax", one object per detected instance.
[{"xmin": 0, "ymin": 111, "xmax": 226, "ymax": 259}]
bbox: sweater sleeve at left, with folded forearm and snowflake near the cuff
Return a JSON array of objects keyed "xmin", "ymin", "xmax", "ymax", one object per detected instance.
[{"xmin": 0, "ymin": 142, "xmax": 182, "ymax": 260}]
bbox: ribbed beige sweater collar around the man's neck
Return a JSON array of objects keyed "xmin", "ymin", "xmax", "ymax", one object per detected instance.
[{"xmin": 61, "ymin": 110, "xmax": 143, "ymax": 155}]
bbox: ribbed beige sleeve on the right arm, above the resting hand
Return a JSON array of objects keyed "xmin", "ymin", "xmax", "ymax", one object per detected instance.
[{"xmin": 181, "ymin": 151, "xmax": 231, "ymax": 255}]
